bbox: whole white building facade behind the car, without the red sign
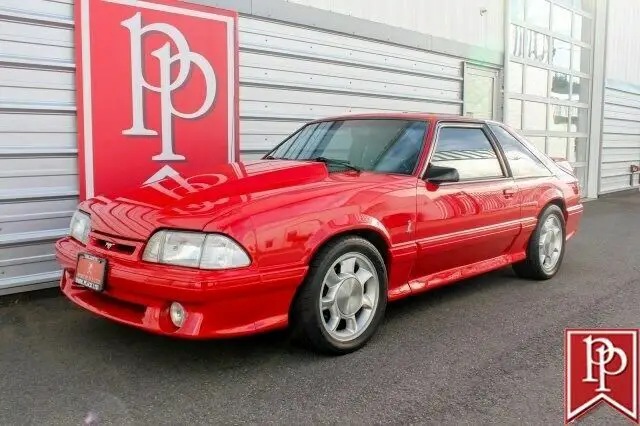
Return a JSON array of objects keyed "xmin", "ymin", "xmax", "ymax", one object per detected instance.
[{"xmin": 0, "ymin": 0, "xmax": 640, "ymax": 294}]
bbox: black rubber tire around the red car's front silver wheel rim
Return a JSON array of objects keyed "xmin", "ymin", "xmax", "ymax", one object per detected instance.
[{"xmin": 291, "ymin": 236, "xmax": 387, "ymax": 355}]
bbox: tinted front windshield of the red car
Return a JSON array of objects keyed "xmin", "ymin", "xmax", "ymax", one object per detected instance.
[{"xmin": 266, "ymin": 119, "xmax": 427, "ymax": 174}]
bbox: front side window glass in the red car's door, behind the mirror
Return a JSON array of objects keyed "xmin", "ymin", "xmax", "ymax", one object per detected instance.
[{"xmin": 431, "ymin": 127, "xmax": 505, "ymax": 180}]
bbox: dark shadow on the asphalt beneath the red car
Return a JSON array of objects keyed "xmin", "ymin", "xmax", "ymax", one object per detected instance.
[{"xmin": 66, "ymin": 268, "xmax": 527, "ymax": 362}]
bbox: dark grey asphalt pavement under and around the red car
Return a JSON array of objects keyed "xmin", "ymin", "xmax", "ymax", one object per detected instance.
[{"xmin": 0, "ymin": 194, "xmax": 640, "ymax": 426}]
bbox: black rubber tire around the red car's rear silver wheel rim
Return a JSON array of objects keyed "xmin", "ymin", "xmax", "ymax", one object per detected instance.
[{"xmin": 513, "ymin": 204, "xmax": 566, "ymax": 280}]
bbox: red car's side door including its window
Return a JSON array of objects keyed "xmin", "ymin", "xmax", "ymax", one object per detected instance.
[{"xmin": 412, "ymin": 123, "xmax": 521, "ymax": 279}]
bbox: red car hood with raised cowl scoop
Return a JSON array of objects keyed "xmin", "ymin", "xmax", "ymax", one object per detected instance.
[{"xmin": 80, "ymin": 160, "xmax": 380, "ymax": 241}]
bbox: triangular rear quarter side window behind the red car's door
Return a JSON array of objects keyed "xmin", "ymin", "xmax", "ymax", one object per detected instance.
[{"xmin": 489, "ymin": 124, "xmax": 551, "ymax": 178}]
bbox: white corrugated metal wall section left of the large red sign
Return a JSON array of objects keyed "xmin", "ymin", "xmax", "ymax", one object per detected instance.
[{"xmin": 0, "ymin": 0, "xmax": 78, "ymax": 294}]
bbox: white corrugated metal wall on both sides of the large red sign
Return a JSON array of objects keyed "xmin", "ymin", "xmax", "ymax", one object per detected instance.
[{"xmin": 0, "ymin": 0, "xmax": 462, "ymax": 294}]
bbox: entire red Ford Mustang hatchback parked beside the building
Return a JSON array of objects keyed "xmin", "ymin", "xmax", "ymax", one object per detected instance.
[{"xmin": 56, "ymin": 114, "xmax": 582, "ymax": 353}]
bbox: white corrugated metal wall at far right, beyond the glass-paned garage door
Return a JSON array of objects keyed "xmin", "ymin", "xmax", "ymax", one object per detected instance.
[{"xmin": 599, "ymin": 82, "xmax": 640, "ymax": 194}]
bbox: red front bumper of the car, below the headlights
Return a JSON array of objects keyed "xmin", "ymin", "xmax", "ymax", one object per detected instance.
[{"xmin": 56, "ymin": 238, "xmax": 307, "ymax": 339}]
